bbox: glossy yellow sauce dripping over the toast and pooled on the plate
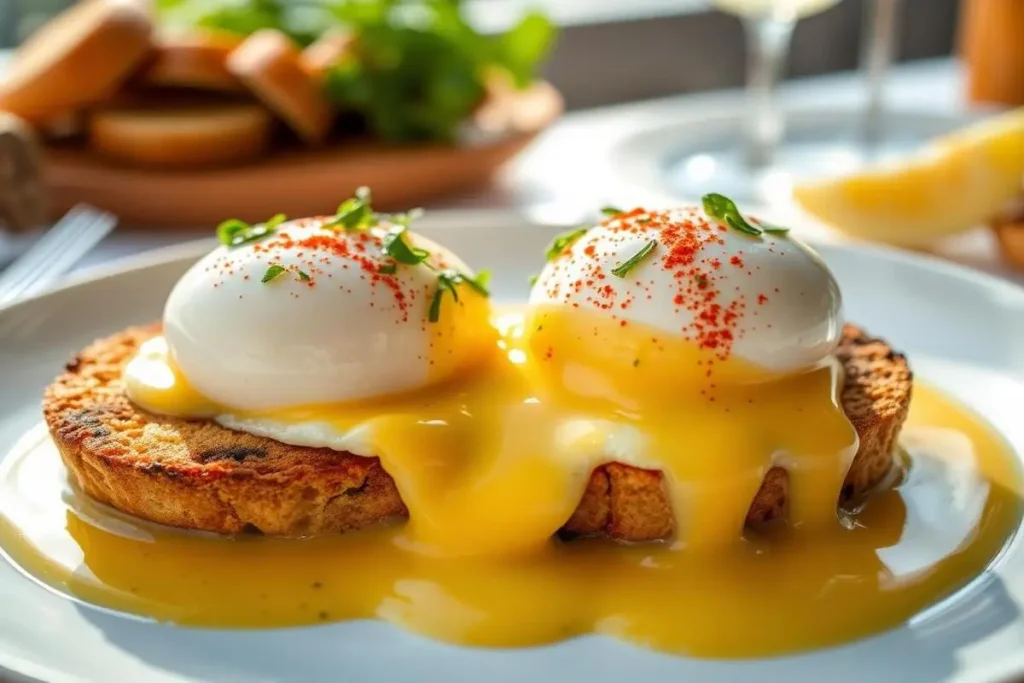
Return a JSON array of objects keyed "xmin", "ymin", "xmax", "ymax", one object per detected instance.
[{"xmin": 0, "ymin": 313, "xmax": 1022, "ymax": 656}]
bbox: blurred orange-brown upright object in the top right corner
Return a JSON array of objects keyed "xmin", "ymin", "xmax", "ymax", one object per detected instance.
[{"xmin": 961, "ymin": 0, "xmax": 1024, "ymax": 105}]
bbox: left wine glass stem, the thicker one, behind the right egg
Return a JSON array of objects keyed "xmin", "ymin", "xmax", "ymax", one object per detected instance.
[{"xmin": 743, "ymin": 17, "xmax": 796, "ymax": 168}]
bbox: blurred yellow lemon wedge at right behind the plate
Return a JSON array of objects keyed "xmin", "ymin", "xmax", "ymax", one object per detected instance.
[{"xmin": 794, "ymin": 108, "xmax": 1024, "ymax": 246}]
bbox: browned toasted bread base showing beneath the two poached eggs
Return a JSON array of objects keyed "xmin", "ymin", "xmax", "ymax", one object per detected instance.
[{"xmin": 43, "ymin": 326, "xmax": 911, "ymax": 541}]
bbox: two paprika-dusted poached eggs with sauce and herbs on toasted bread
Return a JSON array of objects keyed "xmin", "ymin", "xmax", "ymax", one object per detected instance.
[{"xmin": 45, "ymin": 190, "xmax": 910, "ymax": 555}]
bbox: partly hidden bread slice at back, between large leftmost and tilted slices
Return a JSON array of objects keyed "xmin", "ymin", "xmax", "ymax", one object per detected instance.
[{"xmin": 139, "ymin": 31, "xmax": 246, "ymax": 93}]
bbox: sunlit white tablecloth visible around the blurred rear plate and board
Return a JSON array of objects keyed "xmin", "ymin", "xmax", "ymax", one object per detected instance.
[{"xmin": 51, "ymin": 59, "xmax": 1024, "ymax": 284}]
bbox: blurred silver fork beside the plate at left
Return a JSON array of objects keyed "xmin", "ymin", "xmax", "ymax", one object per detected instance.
[{"xmin": 0, "ymin": 204, "xmax": 118, "ymax": 306}]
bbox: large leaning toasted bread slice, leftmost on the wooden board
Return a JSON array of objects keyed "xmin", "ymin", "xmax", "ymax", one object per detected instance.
[{"xmin": 0, "ymin": 0, "xmax": 153, "ymax": 121}]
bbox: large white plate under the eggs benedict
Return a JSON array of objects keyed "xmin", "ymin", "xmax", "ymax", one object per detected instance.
[{"xmin": 0, "ymin": 213, "xmax": 1024, "ymax": 683}]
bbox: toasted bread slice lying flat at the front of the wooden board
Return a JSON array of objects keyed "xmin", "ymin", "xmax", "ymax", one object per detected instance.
[{"xmin": 89, "ymin": 102, "xmax": 273, "ymax": 168}]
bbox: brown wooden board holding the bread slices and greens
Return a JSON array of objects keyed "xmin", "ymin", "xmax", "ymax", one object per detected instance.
[{"xmin": 44, "ymin": 86, "xmax": 562, "ymax": 227}]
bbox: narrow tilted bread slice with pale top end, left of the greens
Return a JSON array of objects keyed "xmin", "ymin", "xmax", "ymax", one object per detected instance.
[{"xmin": 227, "ymin": 29, "xmax": 334, "ymax": 144}]
